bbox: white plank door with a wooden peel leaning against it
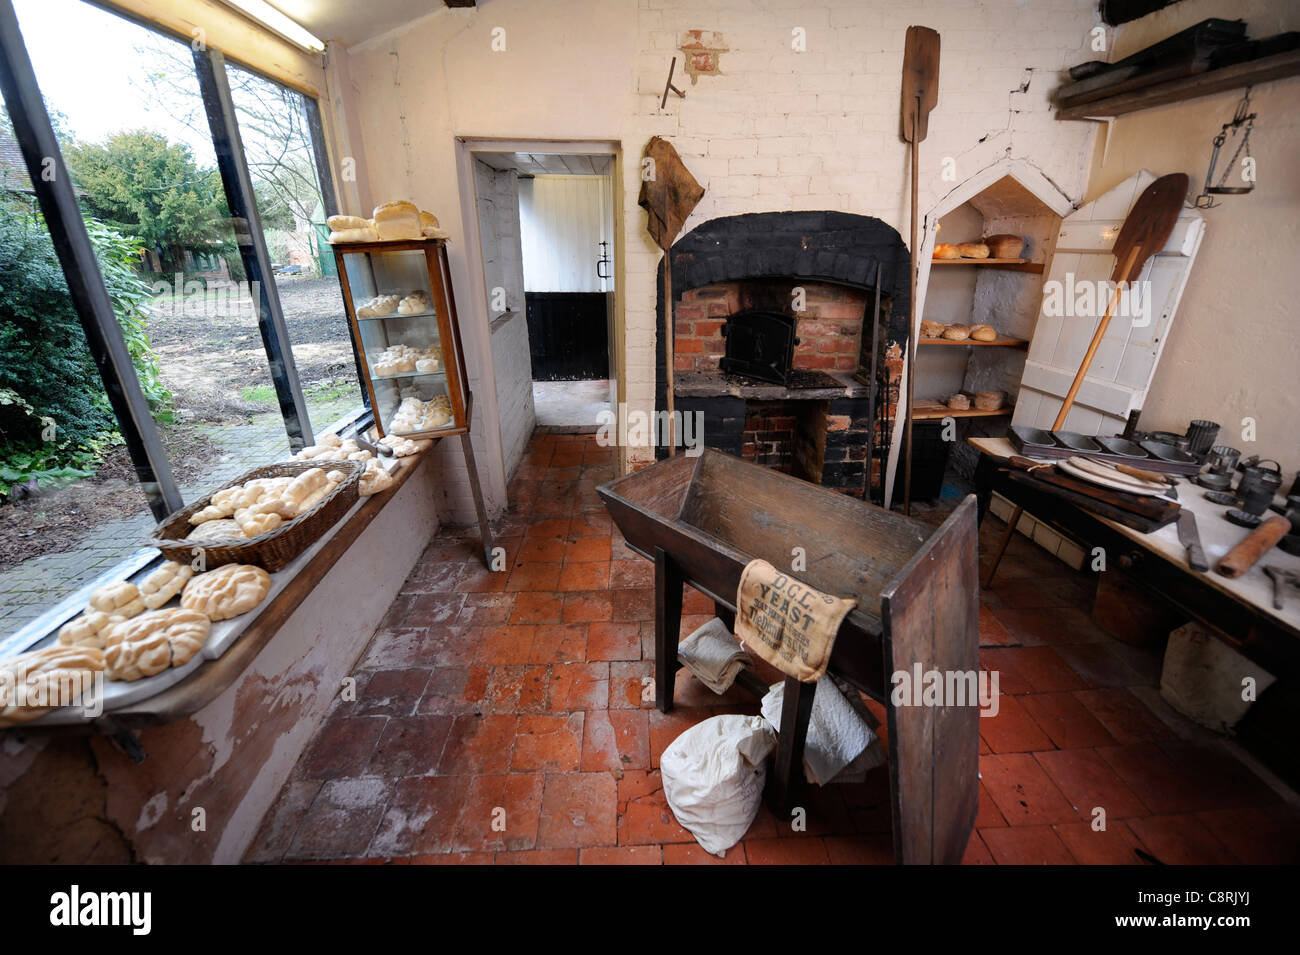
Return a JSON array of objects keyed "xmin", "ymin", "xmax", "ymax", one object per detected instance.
[{"xmin": 1011, "ymin": 169, "xmax": 1205, "ymax": 435}]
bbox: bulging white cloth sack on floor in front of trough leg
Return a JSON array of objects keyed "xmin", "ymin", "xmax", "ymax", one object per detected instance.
[{"xmin": 659, "ymin": 713, "xmax": 776, "ymax": 858}]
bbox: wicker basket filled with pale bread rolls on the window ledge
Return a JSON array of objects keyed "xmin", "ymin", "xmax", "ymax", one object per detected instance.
[{"xmin": 147, "ymin": 459, "xmax": 365, "ymax": 572}]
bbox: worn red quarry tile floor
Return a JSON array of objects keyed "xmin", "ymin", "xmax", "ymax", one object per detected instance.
[{"xmin": 246, "ymin": 435, "xmax": 1300, "ymax": 865}]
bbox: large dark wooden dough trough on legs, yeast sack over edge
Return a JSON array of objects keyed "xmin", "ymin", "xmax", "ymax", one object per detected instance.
[{"xmin": 598, "ymin": 450, "xmax": 979, "ymax": 864}]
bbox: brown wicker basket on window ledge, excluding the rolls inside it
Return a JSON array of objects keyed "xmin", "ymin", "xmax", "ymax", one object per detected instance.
[{"xmin": 146, "ymin": 461, "xmax": 365, "ymax": 572}]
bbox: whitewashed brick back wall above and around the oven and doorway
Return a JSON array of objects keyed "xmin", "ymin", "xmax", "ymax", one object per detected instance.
[{"xmin": 348, "ymin": 0, "xmax": 1100, "ymax": 480}]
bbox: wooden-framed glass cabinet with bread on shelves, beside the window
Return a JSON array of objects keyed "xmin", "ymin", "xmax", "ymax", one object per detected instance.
[{"xmin": 333, "ymin": 239, "xmax": 471, "ymax": 439}]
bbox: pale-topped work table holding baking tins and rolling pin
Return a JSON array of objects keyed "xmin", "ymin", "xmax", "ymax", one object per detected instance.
[{"xmin": 969, "ymin": 438, "xmax": 1300, "ymax": 677}]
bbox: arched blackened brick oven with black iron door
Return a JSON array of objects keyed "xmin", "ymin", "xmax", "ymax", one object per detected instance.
[{"xmin": 657, "ymin": 212, "xmax": 911, "ymax": 498}]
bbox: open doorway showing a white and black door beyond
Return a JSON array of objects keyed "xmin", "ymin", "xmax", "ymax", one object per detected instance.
[{"xmin": 471, "ymin": 144, "xmax": 618, "ymax": 433}]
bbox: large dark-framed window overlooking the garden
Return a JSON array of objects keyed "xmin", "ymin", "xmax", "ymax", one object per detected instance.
[{"xmin": 0, "ymin": 0, "xmax": 363, "ymax": 652}]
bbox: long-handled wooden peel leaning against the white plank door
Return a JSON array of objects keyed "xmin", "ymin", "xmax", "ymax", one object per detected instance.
[{"xmin": 984, "ymin": 173, "xmax": 1188, "ymax": 587}]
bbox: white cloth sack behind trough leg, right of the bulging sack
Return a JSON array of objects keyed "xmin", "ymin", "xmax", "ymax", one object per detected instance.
[{"xmin": 762, "ymin": 677, "xmax": 885, "ymax": 786}]
